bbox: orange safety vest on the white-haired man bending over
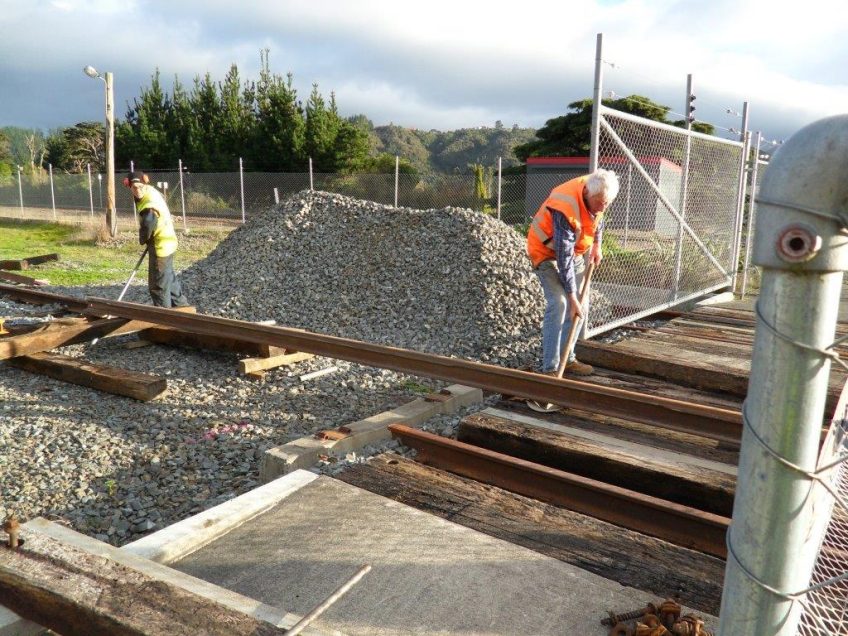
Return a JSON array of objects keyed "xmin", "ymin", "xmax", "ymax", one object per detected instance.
[{"xmin": 527, "ymin": 176, "xmax": 603, "ymax": 267}]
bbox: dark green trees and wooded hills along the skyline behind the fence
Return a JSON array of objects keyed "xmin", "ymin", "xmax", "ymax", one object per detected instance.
[{"xmin": 0, "ymin": 49, "xmax": 714, "ymax": 176}]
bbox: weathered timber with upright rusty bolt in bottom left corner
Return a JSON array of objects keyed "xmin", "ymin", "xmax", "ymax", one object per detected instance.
[{"xmin": 0, "ymin": 527, "xmax": 285, "ymax": 636}]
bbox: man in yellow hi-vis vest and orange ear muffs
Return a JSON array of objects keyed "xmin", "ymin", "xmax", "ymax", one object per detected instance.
[{"xmin": 124, "ymin": 170, "xmax": 188, "ymax": 307}]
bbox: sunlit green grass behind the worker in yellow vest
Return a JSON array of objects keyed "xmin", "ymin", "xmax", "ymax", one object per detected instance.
[{"xmin": 0, "ymin": 220, "xmax": 230, "ymax": 286}]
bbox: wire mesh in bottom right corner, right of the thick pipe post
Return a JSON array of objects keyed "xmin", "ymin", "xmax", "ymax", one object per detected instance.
[{"xmin": 796, "ymin": 414, "xmax": 848, "ymax": 636}]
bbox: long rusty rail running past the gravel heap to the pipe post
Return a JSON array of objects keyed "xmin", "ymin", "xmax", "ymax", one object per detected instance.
[{"xmin": 86, "ymin": 298, "xmax": 742, "ymax": 446}]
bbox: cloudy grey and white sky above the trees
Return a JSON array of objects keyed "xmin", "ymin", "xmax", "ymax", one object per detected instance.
[{"xmin": 0, "ymin": 0, "xmax": 848, "ymax": 149}]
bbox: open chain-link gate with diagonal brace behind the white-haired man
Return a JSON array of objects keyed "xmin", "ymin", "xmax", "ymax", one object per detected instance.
[{"xmin": 585, "ymin": 106, "xmax": 744, "ymax": 337}]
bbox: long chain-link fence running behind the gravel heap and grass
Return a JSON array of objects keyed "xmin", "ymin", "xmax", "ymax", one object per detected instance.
[{"xmin": 0, "ymin": 167, "xmax": 528, "ymax": 229}]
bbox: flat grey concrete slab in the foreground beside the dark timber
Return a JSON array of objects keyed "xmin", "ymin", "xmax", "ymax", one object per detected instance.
[{"xmin": 171, "ymin": 472, "xmax": 715, "ymax": 636}]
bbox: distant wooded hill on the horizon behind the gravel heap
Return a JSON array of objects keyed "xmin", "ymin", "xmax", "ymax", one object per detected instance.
[{"xmin": 351, "ymin": 115, "xmax": 536, "ymax": 174}]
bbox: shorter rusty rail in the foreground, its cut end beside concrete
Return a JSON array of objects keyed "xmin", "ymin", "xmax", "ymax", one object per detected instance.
[{"xmin": 389, "ymin": 424, "xmax": 730, "ymax": 559}]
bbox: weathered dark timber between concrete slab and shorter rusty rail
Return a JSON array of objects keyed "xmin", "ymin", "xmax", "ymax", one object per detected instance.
[{"xmin": 337, "ymin": 455, "xmax": 724, "ymax": 614}]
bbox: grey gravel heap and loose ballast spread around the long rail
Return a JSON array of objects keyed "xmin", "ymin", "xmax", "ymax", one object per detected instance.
[{"xmin": 0, "ymin": 192, "xmax": 603, "ymax": 545}]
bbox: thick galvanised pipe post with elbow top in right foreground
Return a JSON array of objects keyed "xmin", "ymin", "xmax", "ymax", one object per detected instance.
[{"xmin": 719, "ymin": 115, "xmax": 848, "ymax": 636}]
